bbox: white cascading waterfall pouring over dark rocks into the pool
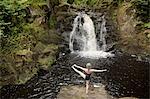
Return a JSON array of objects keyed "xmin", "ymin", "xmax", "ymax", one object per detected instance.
[{"xmin": 69, "ymin": 13, "xmax": 113, "ymax": 58}]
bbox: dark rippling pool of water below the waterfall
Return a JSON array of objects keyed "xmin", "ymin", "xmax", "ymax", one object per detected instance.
[{"xmin": 1, "ymin": 53, "xmax": 150, "ymax": 99}]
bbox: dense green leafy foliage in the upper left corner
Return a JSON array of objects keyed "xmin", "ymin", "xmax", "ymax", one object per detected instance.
[{"xmin": 0, "ymin": 0, "xmax": 28, "ymax": 52}]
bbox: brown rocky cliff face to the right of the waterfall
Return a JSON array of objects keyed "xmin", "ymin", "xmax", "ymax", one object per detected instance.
[{"xmin": 116, "ymin": 1, "xmax": 150, "ymax": 56}]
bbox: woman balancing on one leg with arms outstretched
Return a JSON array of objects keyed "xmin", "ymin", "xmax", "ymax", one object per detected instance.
[{"xmin": 72, "ymin": 63, "xmax": 107, "ymax": 94}]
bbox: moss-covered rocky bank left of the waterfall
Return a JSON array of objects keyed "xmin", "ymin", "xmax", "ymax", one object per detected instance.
[{"xmin": 0, "ymin": 0, "xmax": 62, "ymax": 86}]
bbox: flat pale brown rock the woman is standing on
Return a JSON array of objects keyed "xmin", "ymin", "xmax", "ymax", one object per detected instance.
[{"xmin": 57, "ymin": 84, "xmax": 139, "ymax": 99}]
